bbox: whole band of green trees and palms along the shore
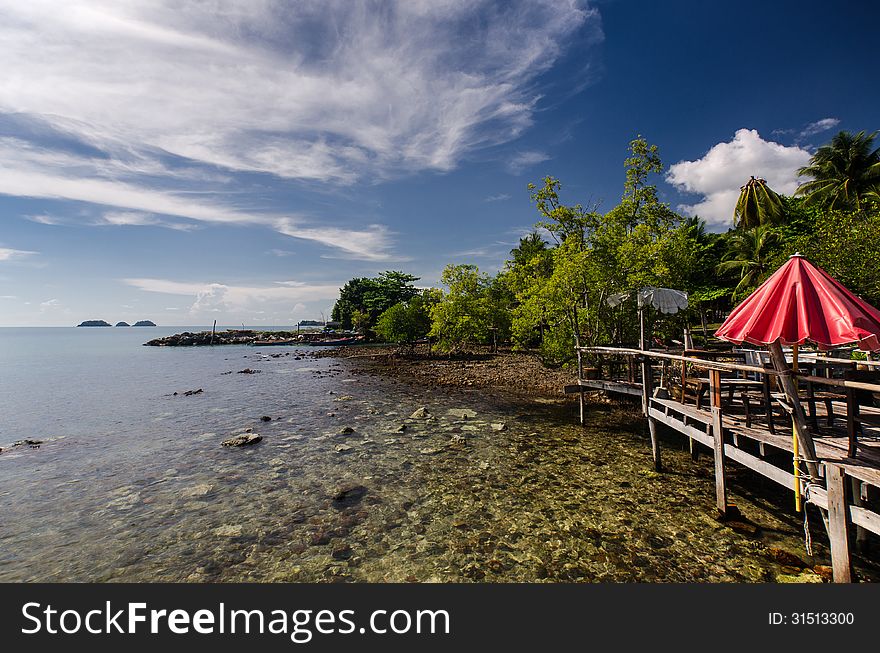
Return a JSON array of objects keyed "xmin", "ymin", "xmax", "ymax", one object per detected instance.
[{"xmin": 333, "ymin": 127, "xmax": 880, "ymax": 364}]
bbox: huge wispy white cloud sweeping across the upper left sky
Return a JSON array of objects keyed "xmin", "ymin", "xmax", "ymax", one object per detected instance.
[{"xmin": 0, "ymin": 0, "xmax": 599, "ymax": 183}]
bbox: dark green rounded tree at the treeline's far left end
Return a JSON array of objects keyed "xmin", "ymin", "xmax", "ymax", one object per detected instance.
[{"xmin": 332, "ymin": 271, "xmax": 419, "ymax": 332}]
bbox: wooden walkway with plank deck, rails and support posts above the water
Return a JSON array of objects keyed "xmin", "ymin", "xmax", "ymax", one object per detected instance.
[{"xmin": 564, "ymin": 347, "xmax": 880, "ymax": 582}]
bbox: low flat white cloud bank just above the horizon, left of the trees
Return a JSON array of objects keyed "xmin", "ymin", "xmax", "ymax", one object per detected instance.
[{"xmin": 122, "ymin": 278, "xmax": 339, "ymax": 316}]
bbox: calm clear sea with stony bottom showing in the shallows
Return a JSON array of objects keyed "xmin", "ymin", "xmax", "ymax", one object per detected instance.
[{"xmin": 0, "ymin": 327, "xmax": 852, "ymax": 582}]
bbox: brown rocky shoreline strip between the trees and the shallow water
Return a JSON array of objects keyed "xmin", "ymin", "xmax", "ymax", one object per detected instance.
[{"xmin": 314, "ymin": 345, "xmax": 577, "ymax": 399}]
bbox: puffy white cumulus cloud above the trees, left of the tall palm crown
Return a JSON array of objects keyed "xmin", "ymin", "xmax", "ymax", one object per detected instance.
[{"xmin": 666, "ymin": 129, "xmax": 810, "ymax": 228}]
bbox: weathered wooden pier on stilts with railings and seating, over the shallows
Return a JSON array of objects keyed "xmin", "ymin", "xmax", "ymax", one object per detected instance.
[{"xmin": 565, "ymin": 347, "xmax": 880, "ymax": 582}]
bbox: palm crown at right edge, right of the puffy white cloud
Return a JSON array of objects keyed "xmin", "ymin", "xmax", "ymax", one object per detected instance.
[{"xmin": 795, "ymin": 131, "xmax": 880, "ymax": 211}]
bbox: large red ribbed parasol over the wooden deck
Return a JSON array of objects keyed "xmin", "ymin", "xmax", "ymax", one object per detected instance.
[{"xmin": 715, "ymin": 254, "xmax": 880, "ymax": 351}]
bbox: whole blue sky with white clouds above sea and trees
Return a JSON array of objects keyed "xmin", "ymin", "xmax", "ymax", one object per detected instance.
[{"xmin": 0, "ymin": 0, "xmax": 880, "ymax": 326}]
